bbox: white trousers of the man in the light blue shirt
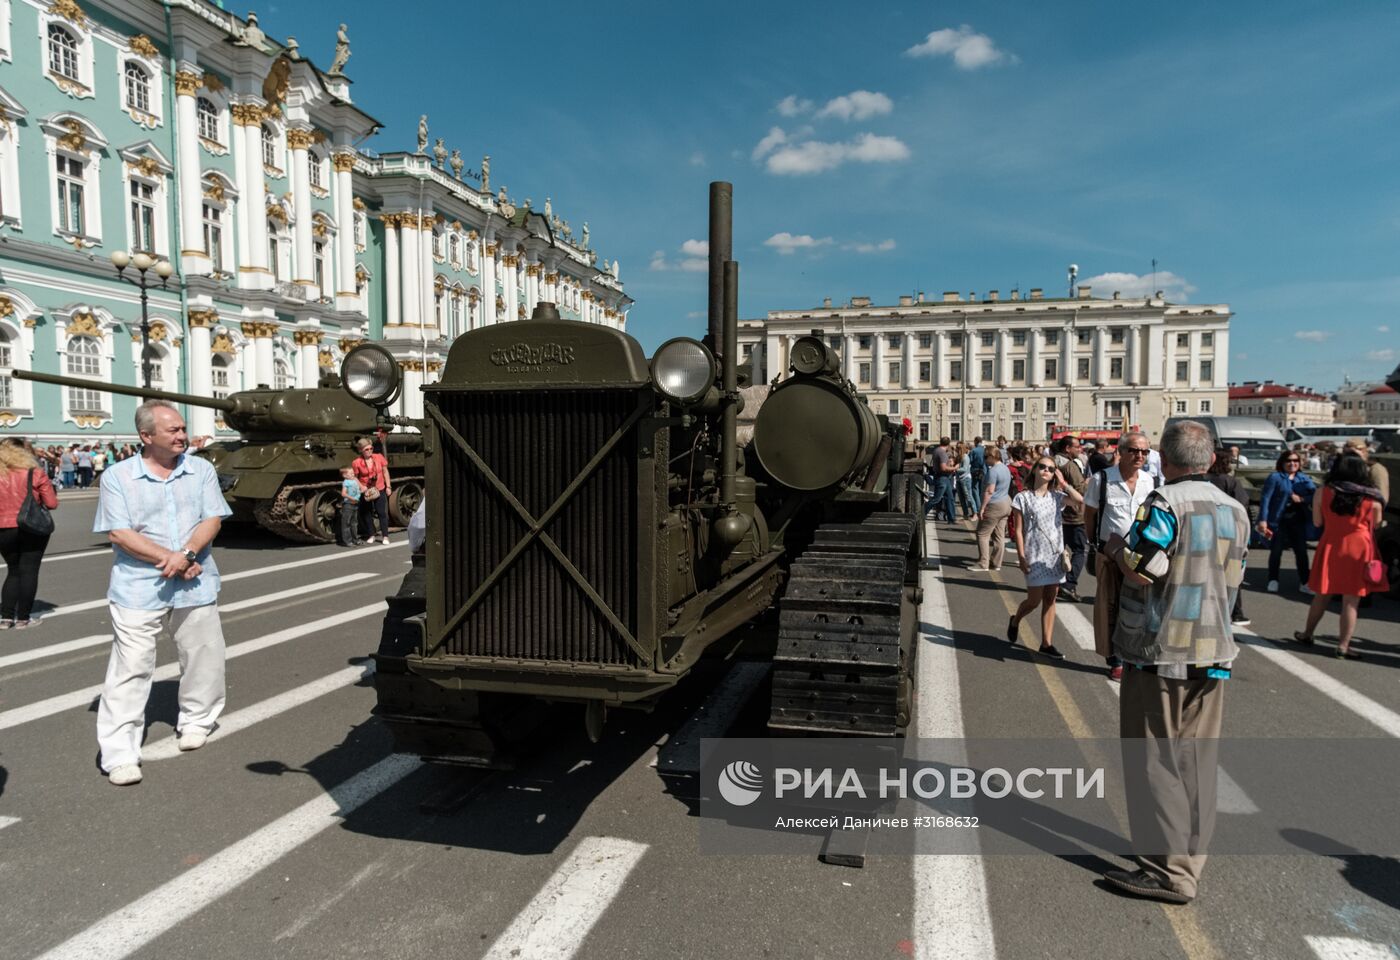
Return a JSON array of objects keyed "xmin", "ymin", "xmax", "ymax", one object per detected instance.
[{"xmin": 97, "ymin": 603, "xmax": 224, "ymax": 772}]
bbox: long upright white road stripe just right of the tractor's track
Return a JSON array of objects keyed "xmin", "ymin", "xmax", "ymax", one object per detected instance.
[{"xmin": 914, "ymin": 522, "xmax": 997, "ymax": 960}]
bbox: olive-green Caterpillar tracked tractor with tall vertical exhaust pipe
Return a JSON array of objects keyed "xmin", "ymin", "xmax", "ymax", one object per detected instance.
[{"xmin": 355, "ymin": 183, "xmax": 923, "ymax": 765}]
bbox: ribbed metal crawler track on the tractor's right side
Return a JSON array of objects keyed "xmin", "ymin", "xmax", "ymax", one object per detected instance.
[{"xmin": 769, "ymin": 512, "xmax": 917, "ymax": 736}]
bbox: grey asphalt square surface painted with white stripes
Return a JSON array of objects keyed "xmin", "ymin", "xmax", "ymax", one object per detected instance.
[{"xmin": 0, "ymin": 494, "xmax": 1400, "ymax": 960}]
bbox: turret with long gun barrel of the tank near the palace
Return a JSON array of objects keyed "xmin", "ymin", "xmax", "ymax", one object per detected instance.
[{"xmin": 14, "ymin": 369, "xmax": 375, "ymax": 435}]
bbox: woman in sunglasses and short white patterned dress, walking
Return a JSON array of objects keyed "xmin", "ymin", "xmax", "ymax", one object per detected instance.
[{"xmin": 1007, "ymin": 456, "xmax": 1084, "ymax": 661}]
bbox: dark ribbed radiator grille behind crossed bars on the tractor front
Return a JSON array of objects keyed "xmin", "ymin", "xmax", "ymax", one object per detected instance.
[{"xmin": 433, "ymin": 390, "xmax": 641, "ymax": 666}]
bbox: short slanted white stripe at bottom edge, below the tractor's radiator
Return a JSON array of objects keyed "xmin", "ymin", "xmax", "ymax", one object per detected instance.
[{"xmin": 484, "ymin": 837, "xmax": 647, "ymax": 960}]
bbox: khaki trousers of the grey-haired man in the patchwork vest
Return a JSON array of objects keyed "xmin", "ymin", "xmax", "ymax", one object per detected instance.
[{"xmin": 1119, "ymin": 666, "xmax": 1225, "ymax": 897}]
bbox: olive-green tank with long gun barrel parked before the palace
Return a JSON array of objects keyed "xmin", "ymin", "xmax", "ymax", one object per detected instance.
[{"xmin": 14, "ymin": 371, "xmax": 423, "ymax": 543}]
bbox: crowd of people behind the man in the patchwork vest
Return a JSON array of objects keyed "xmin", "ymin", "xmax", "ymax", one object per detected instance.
[{"xmin": 923, "ymin": 431, "xmax": 1390, "ymax": 668}]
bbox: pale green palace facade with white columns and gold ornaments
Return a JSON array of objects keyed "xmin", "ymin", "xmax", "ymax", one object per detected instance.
[{"xmin": 0, "ymin": 0, "xmax": 631, "ymax": 442}]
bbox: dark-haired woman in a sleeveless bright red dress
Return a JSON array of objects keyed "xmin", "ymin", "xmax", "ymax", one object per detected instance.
[{"xmin": 1294, "ymin": 455, "xmax": 1390, "ymax": 661}]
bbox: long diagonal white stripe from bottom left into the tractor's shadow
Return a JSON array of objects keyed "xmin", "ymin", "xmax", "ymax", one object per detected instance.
[{"xmin": 30, "ymin": 753, "xmax": 421, "ymax": 960}]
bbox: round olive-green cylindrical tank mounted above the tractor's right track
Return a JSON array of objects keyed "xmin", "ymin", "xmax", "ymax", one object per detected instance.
[{"xmin": 753, "ymin": 376, "xmax": 879, "ymax": 490}]
